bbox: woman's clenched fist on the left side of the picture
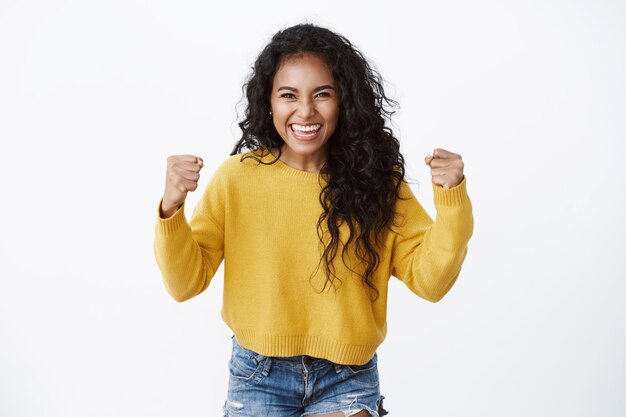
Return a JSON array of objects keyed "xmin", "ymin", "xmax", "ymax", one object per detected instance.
[{"xmin": 161, "ymin": 155, "xmax": 204, "ymax": 218}]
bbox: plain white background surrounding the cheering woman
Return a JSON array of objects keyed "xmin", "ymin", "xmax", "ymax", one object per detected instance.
[{"xmin": 0, "ymin": 0, "xmax": 626, "ymax": 417}]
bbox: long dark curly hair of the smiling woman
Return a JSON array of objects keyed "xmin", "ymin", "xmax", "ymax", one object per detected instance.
[{"xmin": 231, "ymin": 23, "xmax": 405, "ymax": 300}]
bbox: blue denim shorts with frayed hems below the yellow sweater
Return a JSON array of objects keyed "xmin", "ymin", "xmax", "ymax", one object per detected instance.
[{"xmin": 223, "ymin": 335, "xmax": 387, "ymax": 417}]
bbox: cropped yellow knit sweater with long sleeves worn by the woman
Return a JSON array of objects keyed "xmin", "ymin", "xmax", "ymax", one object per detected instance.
[{"xmin": 154, "ymin": 150, "xmax": 474, "ymax": 365}]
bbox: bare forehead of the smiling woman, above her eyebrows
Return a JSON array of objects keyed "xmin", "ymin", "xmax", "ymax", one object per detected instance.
[{"xmin": 274, "ymin": 53, "xmax": 333, "ymax": 88}]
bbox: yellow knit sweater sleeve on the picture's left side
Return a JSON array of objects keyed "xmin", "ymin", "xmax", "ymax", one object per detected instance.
[{"xmin": 154, "ymin": 163, "xmax": 224, "ymax": 302}]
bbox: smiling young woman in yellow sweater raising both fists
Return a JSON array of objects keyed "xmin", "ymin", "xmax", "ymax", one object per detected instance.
[{"xmin": 154, "ymin": 24, "xmax": 473, "ymax": 417}]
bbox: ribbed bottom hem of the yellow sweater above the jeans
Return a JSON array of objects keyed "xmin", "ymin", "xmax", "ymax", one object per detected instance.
[{"xmin": 233, "ymin": 329, "xmax": 382, "ymax": 365}]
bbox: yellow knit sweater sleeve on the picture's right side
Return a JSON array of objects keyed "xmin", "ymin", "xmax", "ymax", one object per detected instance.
[{"xmin": 391, "ymin": 177, "xmax": 474, "ymax": 303}]
